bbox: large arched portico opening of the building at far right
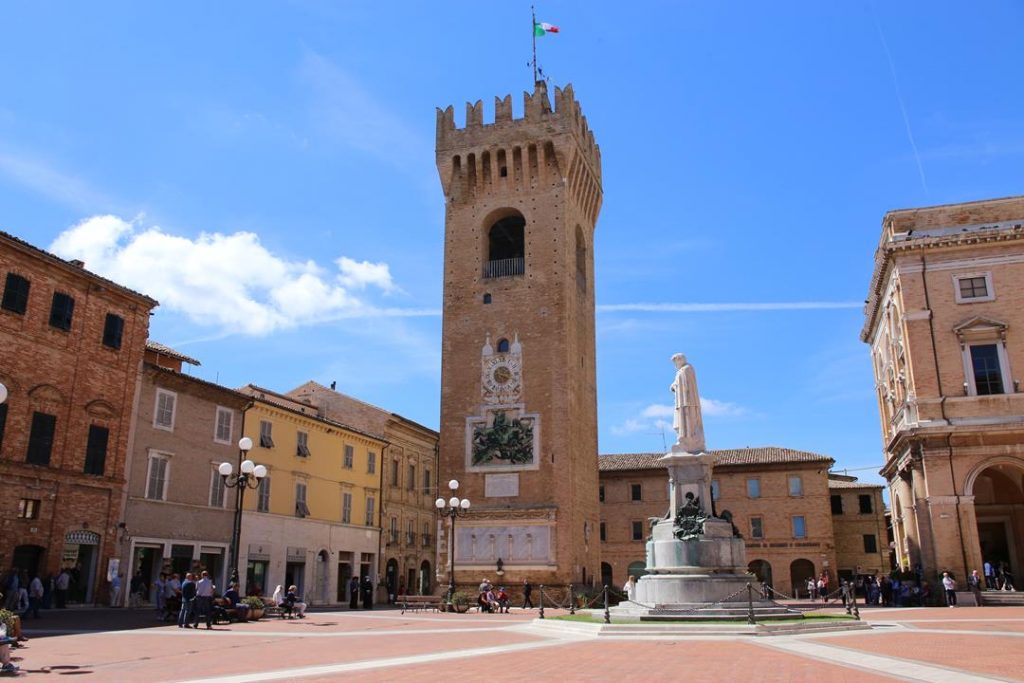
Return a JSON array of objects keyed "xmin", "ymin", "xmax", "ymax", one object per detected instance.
[{"xmin": 970, "ymin": 462, "xmax": 1024, "ymax": 588}]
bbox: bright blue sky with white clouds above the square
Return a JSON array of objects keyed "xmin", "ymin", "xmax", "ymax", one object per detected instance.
[{"xmin": 0, "ymin": 0, "xmax": 1024, "ymax": 485}]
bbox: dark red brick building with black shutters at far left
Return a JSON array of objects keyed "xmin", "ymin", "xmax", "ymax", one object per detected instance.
[{"xmin": 0, "ymin": 233, "xmax": 157, "ymax": 602}]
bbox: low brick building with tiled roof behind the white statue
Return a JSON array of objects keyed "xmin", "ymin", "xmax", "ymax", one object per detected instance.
[{"xmin": 598, "ymin": 447, "xmax": 839, "ymax": 595}]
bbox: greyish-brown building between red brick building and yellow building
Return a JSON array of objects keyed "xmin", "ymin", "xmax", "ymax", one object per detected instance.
[{"xmin": 122, "ymin": 341, "xmax": 250, "ymax": 599}]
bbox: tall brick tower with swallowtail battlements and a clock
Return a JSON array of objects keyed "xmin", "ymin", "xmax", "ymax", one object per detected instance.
[{"xmin": 436, "ymin": 82, "xmax": 602, "ymax": 585}]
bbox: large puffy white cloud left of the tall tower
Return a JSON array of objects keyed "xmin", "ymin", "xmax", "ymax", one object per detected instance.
[{"xmin": 50, "ymin": 215, "xmax": 399, "ymax": 335}]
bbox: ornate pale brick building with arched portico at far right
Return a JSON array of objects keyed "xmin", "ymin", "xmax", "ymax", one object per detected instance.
[{"xmin": 861, "ymin": 197, "xmax": 1024, "ymax": 582}]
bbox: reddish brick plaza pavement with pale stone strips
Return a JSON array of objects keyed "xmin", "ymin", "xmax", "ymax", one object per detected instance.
[{"xmin": 14, "ymin": 607, "xmax": 1024, "ymax": 683}]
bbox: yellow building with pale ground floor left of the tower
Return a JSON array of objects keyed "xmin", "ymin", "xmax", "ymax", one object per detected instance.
[{"xmin": 239, "ymin": 384, "xmax": 387, "ymax": 605}]
